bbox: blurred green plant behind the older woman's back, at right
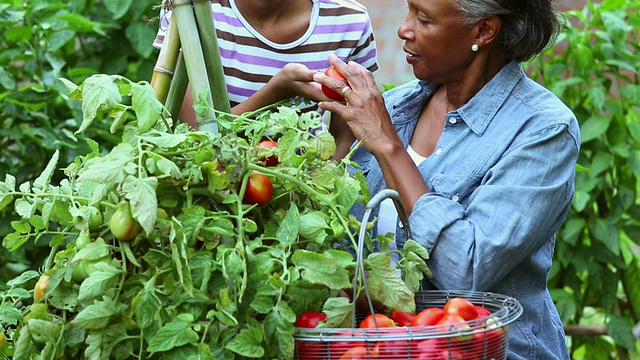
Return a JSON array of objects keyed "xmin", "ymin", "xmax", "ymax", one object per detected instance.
[{"xmin": 527, "ymin": 0, "xmax": 640, "ymax": 359}]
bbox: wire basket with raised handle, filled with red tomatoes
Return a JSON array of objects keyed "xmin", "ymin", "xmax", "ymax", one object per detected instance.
[{"xmin": 294, "ymin": 190, "xmax": 523, "ymax": 360}]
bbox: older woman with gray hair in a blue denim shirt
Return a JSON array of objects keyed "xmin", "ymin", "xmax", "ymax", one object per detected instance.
[{"xmin": 314, "ymin": 0, "xmax": 580, "ymax": 359}]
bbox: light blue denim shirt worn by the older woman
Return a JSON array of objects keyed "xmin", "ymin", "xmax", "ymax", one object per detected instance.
[{"xmin": 352, "ymin": 62, "xmax": 580, "ymax": 360}]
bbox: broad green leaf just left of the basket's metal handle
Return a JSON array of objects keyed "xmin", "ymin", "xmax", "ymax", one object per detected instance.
[{"xmin": 291, "ymin": 250, "xmax": 352, "ymax": 290}]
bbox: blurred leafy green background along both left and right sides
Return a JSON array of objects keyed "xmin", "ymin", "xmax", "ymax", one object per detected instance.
[{"xmin": 0, "ymin": 0, "xmax": 640, "ymax": 359}]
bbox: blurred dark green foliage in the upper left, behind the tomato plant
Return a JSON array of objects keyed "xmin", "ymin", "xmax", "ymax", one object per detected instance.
[{"xmin": 0, "ymin": 0, "xmax": 159, "ymax": 288}]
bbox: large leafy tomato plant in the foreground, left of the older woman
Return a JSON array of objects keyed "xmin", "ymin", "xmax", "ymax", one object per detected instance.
[{"xmin": 0, "ymin": 75, "xmax": 426, "ymax": 359}]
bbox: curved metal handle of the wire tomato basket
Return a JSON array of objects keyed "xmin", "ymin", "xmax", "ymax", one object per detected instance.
[{"xmin": 352, "ymin": 189, "xmax": 411, "ymax": 328}]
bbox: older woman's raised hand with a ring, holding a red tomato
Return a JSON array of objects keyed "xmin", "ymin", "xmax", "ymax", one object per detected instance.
[{"xmin": 313, "ymin": 55, "xmax": 402, "ymax": 155}]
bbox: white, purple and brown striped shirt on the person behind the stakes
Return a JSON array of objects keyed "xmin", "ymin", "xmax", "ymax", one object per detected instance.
[{"xmin": 153, "ymin": 0, "xmax": 378, "ymax": 106}]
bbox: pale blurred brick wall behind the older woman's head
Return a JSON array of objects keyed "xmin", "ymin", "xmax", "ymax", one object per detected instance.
[{"xmin": 359, "ymin": 0, "xmax": 585, "ymax": 85}]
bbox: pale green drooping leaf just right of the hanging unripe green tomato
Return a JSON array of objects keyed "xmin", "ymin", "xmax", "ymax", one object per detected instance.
[{"xmin": 122, "ymin": 176, "xmax": 158, "ymax": 235}]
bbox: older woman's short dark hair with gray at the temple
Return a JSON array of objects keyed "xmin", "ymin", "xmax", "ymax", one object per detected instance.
[{"xmin": 453, "ymin": 0, "xmax": 562, "ymax": 61}]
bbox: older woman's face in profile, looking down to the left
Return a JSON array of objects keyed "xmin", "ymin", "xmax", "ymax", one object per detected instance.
[{"xmin": 398, "ymin": 0, "xmax": 474, "ymax": 83}]
